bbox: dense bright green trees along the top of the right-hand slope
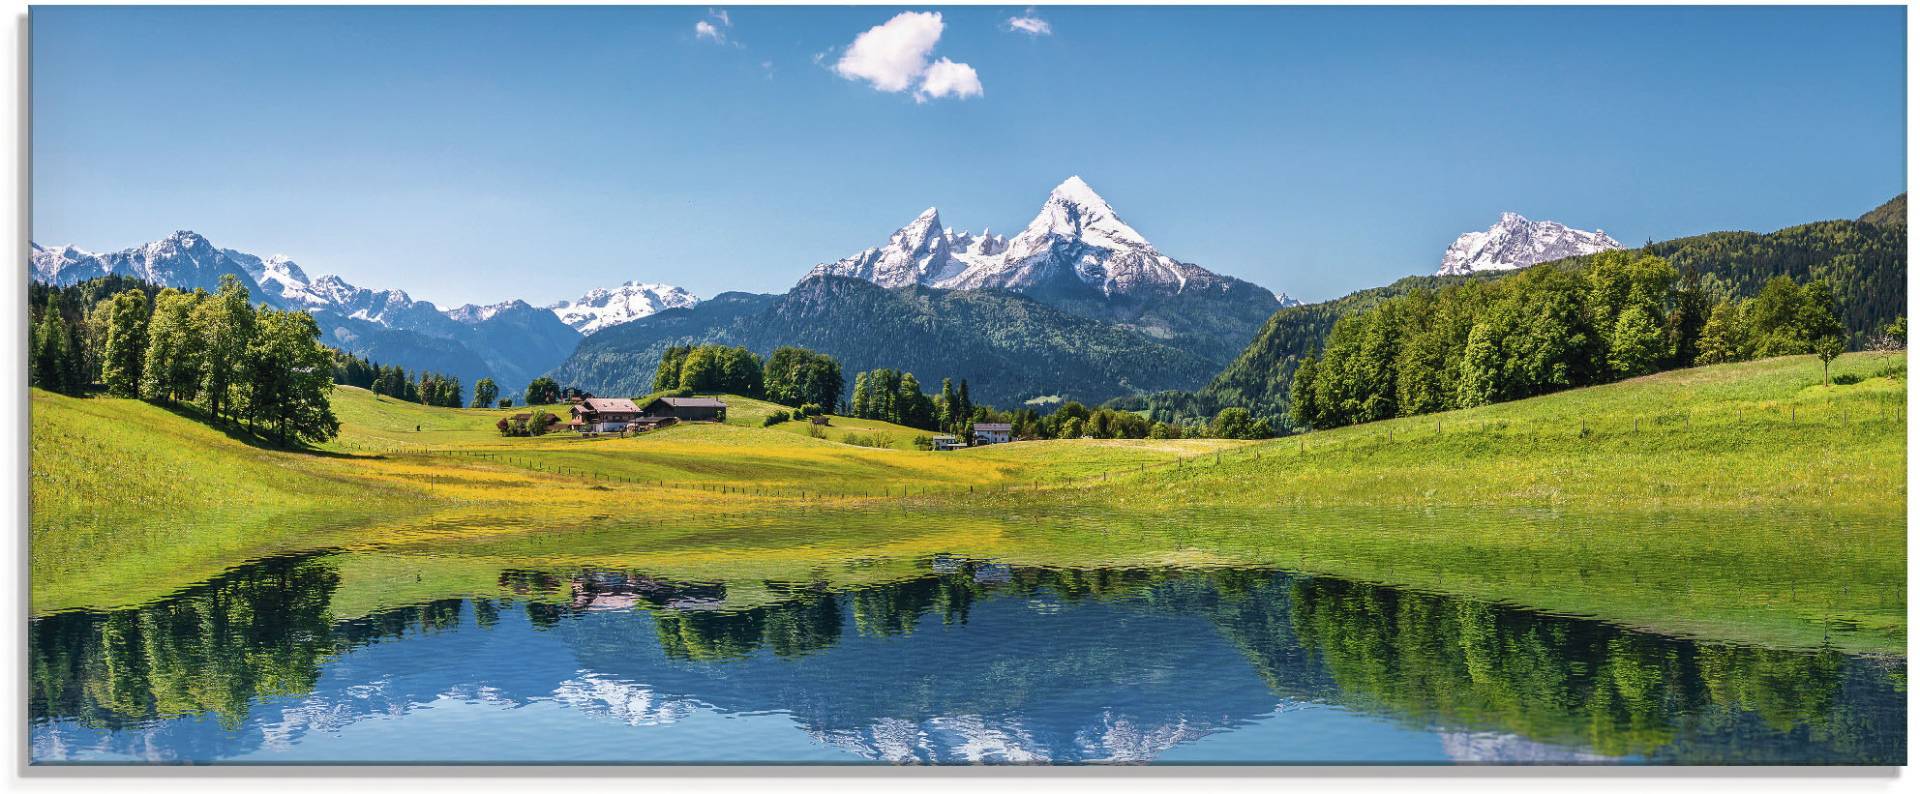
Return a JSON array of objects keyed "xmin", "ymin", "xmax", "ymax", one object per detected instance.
[{"xmin": 1288, "ymin": 251, "xmax": 1845, "ymax": 428}]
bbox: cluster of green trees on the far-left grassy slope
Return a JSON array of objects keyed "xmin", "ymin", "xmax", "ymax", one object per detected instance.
[{"xmin": 27, "ymin": 276, "xmax": 340, "ymax": 443}]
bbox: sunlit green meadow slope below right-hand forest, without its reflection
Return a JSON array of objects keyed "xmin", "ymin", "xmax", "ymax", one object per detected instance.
[{"xmin": 1102, "ymin": 353, "xmax": 1907, "ymax": 510}]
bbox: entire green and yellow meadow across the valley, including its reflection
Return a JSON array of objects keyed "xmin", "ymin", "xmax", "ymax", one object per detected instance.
[{"xmin": 33, "ymin": 355, "xmax": 1907, "ymax": 654}]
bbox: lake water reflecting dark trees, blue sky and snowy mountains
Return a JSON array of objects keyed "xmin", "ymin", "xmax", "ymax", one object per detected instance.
[{"xmin": 29, "ymin": 556, "xmax": 1907, "ymax": 763}]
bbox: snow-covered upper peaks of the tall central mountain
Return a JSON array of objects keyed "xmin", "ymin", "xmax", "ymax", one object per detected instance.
[{"xmin": 808, "ymin": 176, "xmax": 1292, "ymax": 307}]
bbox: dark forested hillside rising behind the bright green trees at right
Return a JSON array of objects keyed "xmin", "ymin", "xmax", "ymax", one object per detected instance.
[{"xmin": 1196, "ymin": 194, "xmax": 1907, "ymax": 416}]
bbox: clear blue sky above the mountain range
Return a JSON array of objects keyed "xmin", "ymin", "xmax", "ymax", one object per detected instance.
[{"xmin": 31, "ymin": 6, "xmax": 1907, "ymax": 305}]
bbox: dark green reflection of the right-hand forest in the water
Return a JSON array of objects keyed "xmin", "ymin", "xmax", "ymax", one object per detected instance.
[{"xmin": 1267, "ymin": 579, "xmax": 1905, "ymax": 759}]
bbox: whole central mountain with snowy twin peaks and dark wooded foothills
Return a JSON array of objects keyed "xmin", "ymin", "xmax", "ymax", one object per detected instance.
[{"xmin": 555, "ymin": 176, "xmax": 1296, "ymax": 405}]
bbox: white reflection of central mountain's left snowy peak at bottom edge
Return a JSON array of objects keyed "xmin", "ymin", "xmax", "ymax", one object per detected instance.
[{"xmin": 808, "ymin": 715, "xmax": 1050, "ymax": 763}]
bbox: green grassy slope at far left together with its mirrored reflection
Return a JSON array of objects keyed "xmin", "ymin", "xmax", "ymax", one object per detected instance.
[{"xmin": 31, "ymin": 391, "xmax": 424, "ymax": 602}]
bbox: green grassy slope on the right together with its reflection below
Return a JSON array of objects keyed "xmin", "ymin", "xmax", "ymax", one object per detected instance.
[{"xmin": 1008, "ymin": 355, "xmax": 1907, "ymax": 652}]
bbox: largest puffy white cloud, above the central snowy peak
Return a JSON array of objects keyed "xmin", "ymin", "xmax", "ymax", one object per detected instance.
[{"xmin": 833, "ymin": 12, "xmax": 985, "ymax": 102}]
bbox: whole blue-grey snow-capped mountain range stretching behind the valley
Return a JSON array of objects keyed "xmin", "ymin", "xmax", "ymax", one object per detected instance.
[{"xmin": 31, "ymin": 176, "xmax": 1781, "ymax": 416}]
